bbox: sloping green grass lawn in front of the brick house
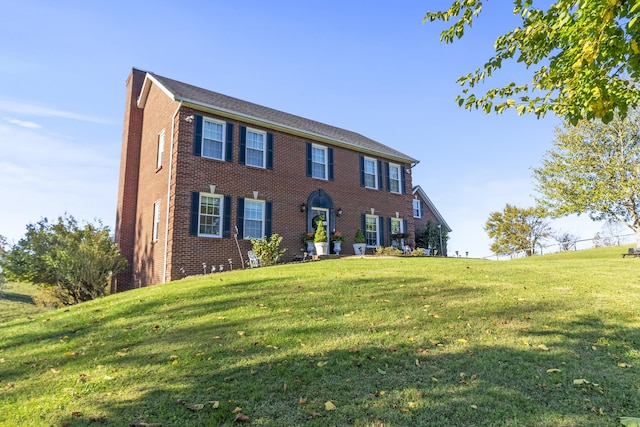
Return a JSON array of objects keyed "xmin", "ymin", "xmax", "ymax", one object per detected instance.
[{"xmin": 0, "ymin": 248, "xmax": 640, "ymax": 427}]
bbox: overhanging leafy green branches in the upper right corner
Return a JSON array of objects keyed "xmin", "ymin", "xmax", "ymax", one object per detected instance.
[{"xmin": 423, "ymin": 0, "xmax": 640, "ymax": 123}]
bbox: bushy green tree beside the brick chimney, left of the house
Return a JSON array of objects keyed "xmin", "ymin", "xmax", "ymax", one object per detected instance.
[{"xmin": 2, "ymin": 216, "xmax": 126, "ymax": 303}]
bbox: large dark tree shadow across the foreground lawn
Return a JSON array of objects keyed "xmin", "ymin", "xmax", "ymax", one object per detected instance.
[{"xmin": 50, "ymin": 316, "xmax": 640, "ymax": 427}]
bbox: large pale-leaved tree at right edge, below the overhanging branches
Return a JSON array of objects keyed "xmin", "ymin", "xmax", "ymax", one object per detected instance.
[{"xmin": 534, "ymin": 110, "xmax": 640, "ymax": 247}]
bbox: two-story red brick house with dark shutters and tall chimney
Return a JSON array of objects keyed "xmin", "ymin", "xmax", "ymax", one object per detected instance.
[{"xmin": 112, "ymin": 69, "xmax": 418, "ymax": 292}]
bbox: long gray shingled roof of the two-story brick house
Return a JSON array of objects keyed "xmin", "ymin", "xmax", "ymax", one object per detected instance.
[{"xmin": 148, "ymin": 73, "xmax": 418, "ymax": 163}]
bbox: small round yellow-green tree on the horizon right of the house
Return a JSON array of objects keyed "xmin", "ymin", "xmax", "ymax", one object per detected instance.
[{"xmin": 484, "ymin": 203, "xmax": 551, "ymax": 256}]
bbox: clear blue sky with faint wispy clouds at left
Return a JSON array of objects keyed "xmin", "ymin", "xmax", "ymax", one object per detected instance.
[{"xmin": 0, "ymin": 0, "xmax": 601, "ymax": 257}]
